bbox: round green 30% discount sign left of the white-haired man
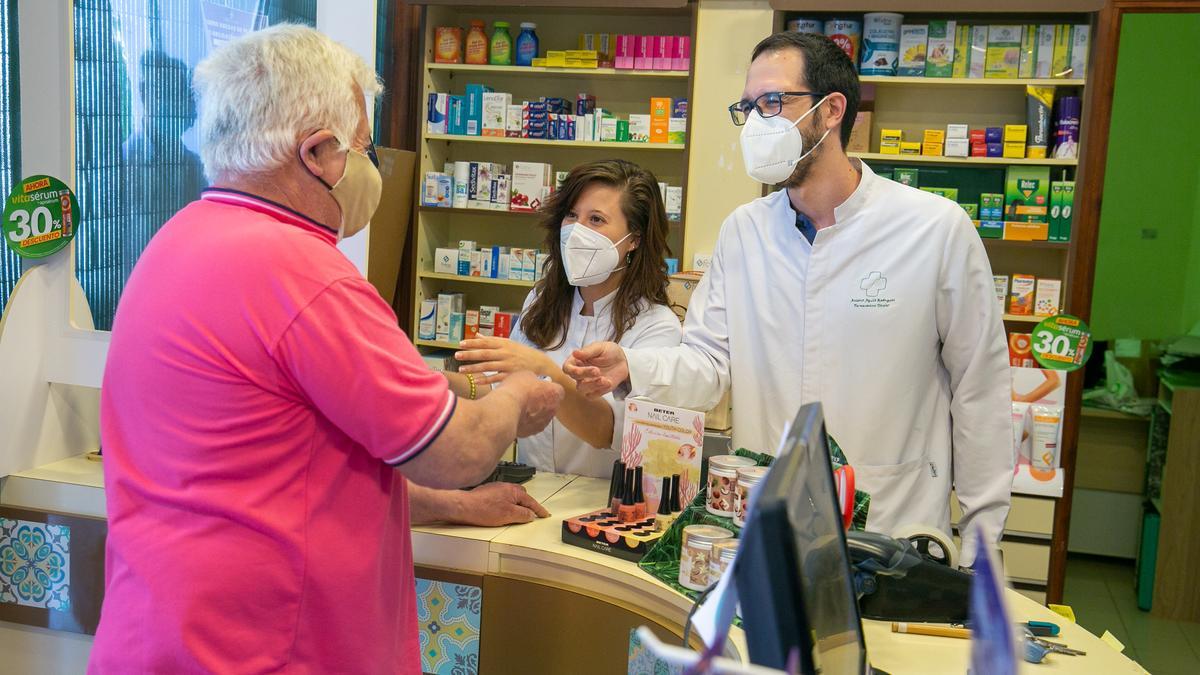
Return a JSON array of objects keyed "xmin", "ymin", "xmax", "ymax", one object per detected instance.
[{"xmin": 0, "ymin": 175, "xmax": 80, "ymax": 258}]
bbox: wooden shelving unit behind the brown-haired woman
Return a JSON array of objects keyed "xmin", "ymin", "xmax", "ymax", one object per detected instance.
[{"xmin": 402, "ymin": 0, "xmax": 696, "ymax": 341}]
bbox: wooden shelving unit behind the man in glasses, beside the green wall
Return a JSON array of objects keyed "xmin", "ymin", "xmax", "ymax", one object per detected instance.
[{"xmin": 770, "ymin": 0, "xmax": 1115, "ymax": 602}]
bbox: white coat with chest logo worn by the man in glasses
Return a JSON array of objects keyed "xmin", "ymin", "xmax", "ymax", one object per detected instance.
[{"xmin": 626, "ymin": 165, "xmax": 1014, "ymax": 563}]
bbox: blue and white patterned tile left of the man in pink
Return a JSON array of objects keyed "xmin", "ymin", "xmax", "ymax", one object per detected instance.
[{"xmin": 0, "ymin": 518, "xmax": 71, "ymax": 611}]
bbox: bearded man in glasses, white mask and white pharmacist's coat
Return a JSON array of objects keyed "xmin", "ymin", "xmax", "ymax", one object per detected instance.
[{"xmin": 564, "ymin": 32, "xmax": 1014, "ymax": 565}]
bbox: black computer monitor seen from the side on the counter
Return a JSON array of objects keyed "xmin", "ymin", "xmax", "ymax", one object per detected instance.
[{"xmin": 733, "ymin": 404, "xmax": 866, "ymax": 675}]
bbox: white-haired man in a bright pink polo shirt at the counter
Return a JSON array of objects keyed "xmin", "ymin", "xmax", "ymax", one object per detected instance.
[{"xmin": 90, "ymin": 25, "xmax": 563, "ymax": 673}]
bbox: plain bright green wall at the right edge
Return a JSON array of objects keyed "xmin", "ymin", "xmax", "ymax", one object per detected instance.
[{"xmin": 1092, "ymin": 13, "xmax": 1200, "ymax": 340}]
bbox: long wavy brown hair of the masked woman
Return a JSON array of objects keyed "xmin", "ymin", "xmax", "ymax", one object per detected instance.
[{"xmin": 521, "ymin": 160, "xmax": 671, "ymax": 350}]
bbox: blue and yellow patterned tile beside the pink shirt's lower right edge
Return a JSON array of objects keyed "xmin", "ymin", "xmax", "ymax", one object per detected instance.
[{"xmin": 416, "ymin": 579, "xmax": 484, "ymax": 675}]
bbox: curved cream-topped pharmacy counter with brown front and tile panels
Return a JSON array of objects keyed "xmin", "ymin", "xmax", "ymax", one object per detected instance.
[{"xmin": 7, "ymin": 458, "xmax": 1142, "ymax": 675}]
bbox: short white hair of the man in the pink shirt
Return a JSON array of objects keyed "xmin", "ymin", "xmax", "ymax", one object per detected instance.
[{"xmin": 193, "ymin": 24, "xmax": 383, "ymax": 181}]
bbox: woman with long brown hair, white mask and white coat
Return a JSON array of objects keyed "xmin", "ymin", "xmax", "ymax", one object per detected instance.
[{"xmin": 449, "ymin": 160, "xmax": 682, "ymax": 478}]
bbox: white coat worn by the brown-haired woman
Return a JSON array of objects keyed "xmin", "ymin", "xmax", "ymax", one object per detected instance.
[{"xmin": 511, "ymin": 285, "xmax": 683, "ymax": 478}]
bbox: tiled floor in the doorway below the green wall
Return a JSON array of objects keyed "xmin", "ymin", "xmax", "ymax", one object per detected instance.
[{"xmin": 1063, "ymin": 556, "xmax": 1200, "ymax": 675}]
